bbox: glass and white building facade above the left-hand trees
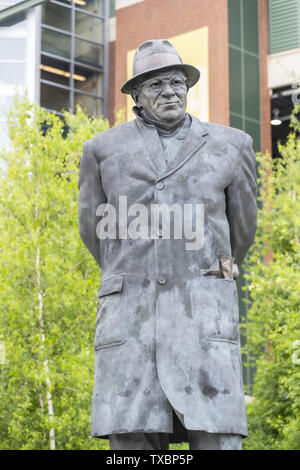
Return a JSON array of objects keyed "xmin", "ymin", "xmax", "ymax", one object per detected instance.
[{"xmin": 0, "ymin": 0, "xmax": 109, "ymax": 140}]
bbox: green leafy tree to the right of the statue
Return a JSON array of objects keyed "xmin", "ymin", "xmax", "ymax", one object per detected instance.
[{"xmin": 244, "ymin": 106, "xmax": 300, "ymax": 449}]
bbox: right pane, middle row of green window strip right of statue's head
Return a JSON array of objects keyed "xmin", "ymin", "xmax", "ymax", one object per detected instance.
[{"xmin": 244, "ymin": 53, "xmax": 260, "ymax": 121}]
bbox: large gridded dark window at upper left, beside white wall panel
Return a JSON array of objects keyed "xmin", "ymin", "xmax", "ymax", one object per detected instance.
[{"xmin": 40, "ymin": 0, "xmax": 108, "ymax": 115}]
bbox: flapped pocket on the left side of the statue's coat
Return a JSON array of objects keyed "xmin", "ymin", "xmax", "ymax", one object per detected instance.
[{"xmin": 94, "ymin": 274, "xmax": 127, "ymax": 351}]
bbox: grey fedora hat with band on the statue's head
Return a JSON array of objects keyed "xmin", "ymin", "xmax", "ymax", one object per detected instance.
[{"xmin": 121, "ymin": 39, "xmax": 200, "ymax": 94}]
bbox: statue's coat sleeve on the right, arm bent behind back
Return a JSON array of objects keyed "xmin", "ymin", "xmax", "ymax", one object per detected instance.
[{"xmin": 225, "ymin": 135, "xmax": 257, "ymax": 265}]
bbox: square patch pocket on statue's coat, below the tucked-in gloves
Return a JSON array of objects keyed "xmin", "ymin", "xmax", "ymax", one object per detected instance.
[{"xmin": 190, "ymin": 276, "xmax": 239, "ymax": 344}]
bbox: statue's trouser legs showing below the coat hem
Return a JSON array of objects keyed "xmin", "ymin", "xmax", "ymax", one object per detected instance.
[{"xmin": 109, "ymin": 431, "xmax": 242, "ymax": 450}]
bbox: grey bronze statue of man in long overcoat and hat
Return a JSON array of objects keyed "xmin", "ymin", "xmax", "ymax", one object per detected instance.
[{"xmin": 79, "ymin": 39, "xmax": 257, "ymax": 450}]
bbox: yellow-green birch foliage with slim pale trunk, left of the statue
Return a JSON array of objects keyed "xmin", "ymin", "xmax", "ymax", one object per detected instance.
[{"xmin": 0, "ymin": 100, "xmax": 109, "ymax": 449}]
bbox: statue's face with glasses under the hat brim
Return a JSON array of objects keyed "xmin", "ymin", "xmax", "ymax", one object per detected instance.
[{"xmin": 135, "ymin": 70, "xmax": 188, "ymax": 125}]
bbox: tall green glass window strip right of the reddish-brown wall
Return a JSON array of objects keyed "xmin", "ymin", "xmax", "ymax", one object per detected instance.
[{"xmin": 228, "ymin": 0, "xmax": 261, "ymax": 393}]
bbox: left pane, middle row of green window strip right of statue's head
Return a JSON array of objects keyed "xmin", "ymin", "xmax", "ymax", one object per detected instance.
[{"xmin": 229, "ymin": 47, "xmax": 242, "ymax": 114}]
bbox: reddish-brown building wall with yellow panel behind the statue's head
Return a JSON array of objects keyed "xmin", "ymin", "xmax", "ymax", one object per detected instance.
[{"xmin": 110, "ymin": 0, "xmax": 269, "ymax": 150}]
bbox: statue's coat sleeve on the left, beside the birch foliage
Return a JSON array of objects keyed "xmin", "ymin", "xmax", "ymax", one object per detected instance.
[{"xmin": 78, "ymin": 141, "xmax": 107, "ymax": 266}]
